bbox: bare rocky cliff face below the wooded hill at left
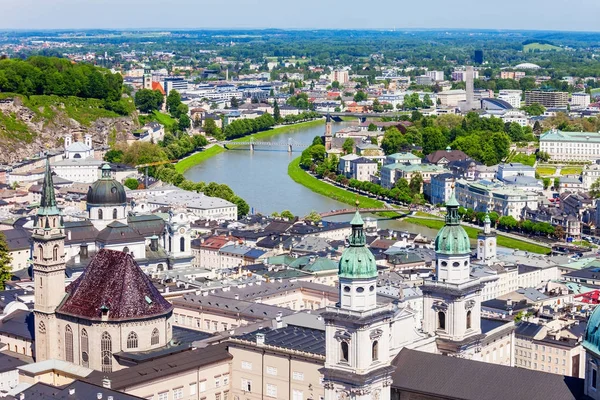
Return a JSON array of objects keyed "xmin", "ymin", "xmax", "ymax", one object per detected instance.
[{"xmin": 0, "ymin": 97, "xmax": 137, "ymax": 164}]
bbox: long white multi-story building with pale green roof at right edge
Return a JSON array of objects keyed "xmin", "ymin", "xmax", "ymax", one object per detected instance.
[{"xmin": 540, "ymin": 129, "xmax": 600, "ymax": 161}]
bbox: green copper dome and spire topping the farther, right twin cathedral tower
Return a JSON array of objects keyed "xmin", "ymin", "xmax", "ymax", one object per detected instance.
[{"xmin": 435, "ymin": 191, "xmax": 471, "ymax": 255}]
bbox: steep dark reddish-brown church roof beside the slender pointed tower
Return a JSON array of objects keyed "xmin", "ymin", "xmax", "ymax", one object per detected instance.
[{"xmin": 58, "ymin": 249, "xmax": 173, "ymax": 320}]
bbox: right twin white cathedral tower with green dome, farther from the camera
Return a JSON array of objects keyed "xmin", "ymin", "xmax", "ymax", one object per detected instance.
[{"xmin": 422, "ymin": 188, "xmax": 482, "ymax": 356}]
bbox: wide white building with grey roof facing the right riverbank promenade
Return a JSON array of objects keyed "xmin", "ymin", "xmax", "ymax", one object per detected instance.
[{"xmin": 456, "ymin": 179, "xmax": 538, "ymax": 219}]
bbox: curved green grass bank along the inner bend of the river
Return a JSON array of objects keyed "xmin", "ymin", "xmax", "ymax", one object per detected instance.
[{"xmin": 288, "ymin": 157, "xmax": 386, "ymax": 209}]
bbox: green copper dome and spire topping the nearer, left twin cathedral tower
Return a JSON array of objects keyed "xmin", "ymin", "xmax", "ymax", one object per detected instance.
[{"xmin": 338, "ymin": 210, "xmax": 377, "ymax": 279}]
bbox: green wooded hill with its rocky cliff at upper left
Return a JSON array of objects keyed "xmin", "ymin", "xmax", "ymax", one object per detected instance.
[{"xmin": 0, "ymin": 56, "xmax": 135, "ymax": 162}]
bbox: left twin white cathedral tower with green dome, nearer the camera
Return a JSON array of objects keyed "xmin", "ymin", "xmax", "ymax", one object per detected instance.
[{"xmin": 321, "ymin": 210, "xmax": 394, "ymax": 400}]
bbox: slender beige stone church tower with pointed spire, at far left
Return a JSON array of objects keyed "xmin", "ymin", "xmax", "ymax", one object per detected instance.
[{"xmin": 32, "ymin": 160, "xmax": 65, "ymax": 361}]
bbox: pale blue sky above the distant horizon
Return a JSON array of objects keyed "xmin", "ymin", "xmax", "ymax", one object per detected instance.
[{"xmin": 0, "ymin": 0, "xmax": 600, "ymax": 31}]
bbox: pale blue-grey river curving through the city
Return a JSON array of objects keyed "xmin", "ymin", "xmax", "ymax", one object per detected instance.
[{"xmin": 184, "ymin": 122, "xmax": 446, "ymax": 238}]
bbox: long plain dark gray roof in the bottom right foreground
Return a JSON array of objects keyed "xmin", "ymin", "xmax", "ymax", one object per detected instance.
[{"xmin": 392, "ymin": 348, "xmax": 583, "ymax": 400}]
